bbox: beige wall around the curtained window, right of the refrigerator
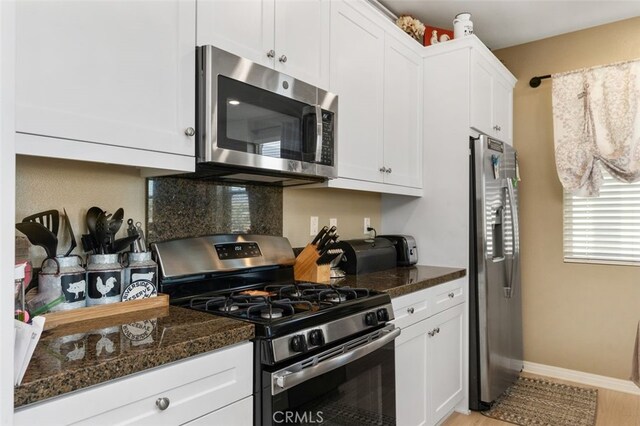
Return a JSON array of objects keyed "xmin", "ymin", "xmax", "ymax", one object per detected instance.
[{"xmin": 495, "ymin": 18, "xmax": 640, "ymax": 379}]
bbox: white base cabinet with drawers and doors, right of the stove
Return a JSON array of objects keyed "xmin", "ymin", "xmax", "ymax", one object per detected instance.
[{"xmin": 392, "ymin": 279, "xmax": 467, "ymax": 426}]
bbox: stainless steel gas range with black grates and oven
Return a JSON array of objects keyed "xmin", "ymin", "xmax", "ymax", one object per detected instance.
[{"xmin": 153, "ymin": 235, "xmax": 400, "ymax": 425}]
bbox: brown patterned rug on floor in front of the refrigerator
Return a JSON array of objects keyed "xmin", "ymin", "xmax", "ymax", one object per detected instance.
[{"xmin": 482, "ymin": 377, "xmax": 598, "ymax": 426}]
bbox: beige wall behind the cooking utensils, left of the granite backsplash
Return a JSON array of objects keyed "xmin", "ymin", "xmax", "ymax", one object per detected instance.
[{"xmin": 16, "ymin": 156, "xmax": 145, "ymax": 267}]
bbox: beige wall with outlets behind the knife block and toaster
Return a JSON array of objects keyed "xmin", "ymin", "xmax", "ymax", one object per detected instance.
[{"xmin": 282, "ymin": 188, "xmax": 380, "ymax": 247}]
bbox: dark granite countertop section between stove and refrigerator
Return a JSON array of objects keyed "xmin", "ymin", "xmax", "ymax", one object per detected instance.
[{"xmin": 331, "ymin": 265, "xmax": 467, "ymax": 298}]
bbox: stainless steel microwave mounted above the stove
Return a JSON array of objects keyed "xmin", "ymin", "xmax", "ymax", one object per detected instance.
[{"xmin": 196, "ymin": 46, "xmax": 338, "ymax": 185}]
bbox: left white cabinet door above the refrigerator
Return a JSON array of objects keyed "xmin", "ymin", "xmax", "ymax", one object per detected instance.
[{"xmin": 469, "ymin": 52, "xmax": 495, "ymax": 136}]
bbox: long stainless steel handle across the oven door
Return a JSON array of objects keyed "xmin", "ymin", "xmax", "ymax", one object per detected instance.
[{"xmin": 271, "ymin": 325, "xmax": 400, "ymax": 395}]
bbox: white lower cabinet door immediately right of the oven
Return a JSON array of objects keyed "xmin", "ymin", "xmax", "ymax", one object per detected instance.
[{"xmin": 395, "ymin": 320, "xmax": 430, "ymax": 426}]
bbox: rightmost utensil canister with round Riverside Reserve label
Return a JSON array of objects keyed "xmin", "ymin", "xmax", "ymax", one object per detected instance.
[{"xmin": 122, "ymin": 251, "xmax": 158, "ymax": 301}]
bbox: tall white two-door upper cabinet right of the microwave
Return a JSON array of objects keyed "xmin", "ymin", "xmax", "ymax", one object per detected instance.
[{"xmin": 306, "ymin": 1, "xmax": 423, "ymax": 195}]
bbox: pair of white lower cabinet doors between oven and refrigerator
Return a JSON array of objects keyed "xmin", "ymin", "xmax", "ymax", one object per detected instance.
[{"xmin": 396, "ymin": 282, "xmax": 467, "ymax": 426}]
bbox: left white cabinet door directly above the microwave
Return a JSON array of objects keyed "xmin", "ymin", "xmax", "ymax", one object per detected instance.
[{"xmin": 196, "ymin": 0, "xmax": 275, "ymax": 67}]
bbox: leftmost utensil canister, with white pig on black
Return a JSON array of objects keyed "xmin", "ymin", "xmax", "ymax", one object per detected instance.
[{"xmin": 38, "ymin": 256, "xmax": 87, "ymax": 311}]
